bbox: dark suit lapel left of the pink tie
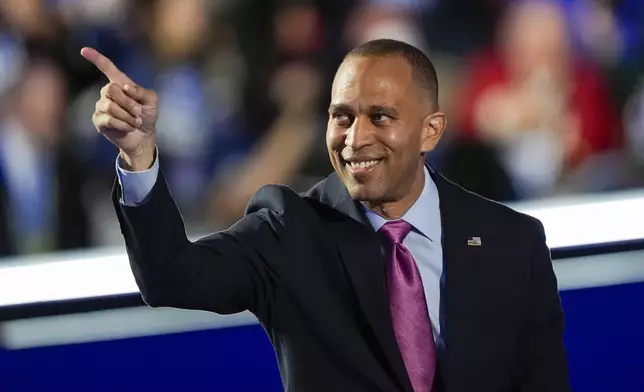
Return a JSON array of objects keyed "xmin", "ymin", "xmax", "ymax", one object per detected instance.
[{"xmin": 320, "ymin": 174, "xmax": 412, "ymax": 392}]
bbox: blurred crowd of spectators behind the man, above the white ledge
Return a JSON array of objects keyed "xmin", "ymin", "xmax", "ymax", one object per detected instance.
[{"xmin": 0, "ymin": 0, "xmax": 644, "ymax": 391}]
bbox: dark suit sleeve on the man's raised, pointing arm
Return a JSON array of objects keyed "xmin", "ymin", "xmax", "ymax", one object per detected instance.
[{"xmin": 112, "ymin": 170, "xmax": 280, "ymax": 315}]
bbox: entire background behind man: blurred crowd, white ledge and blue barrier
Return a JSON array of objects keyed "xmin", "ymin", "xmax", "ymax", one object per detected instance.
[{"xmin": 0, "ymin": 0, "xmax": 644, "ymax": 392}]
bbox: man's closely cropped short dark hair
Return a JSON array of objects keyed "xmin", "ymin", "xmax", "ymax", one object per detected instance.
[{"xmin": 344, "ymin": 39, "xmax": 438, "ymax": 109}]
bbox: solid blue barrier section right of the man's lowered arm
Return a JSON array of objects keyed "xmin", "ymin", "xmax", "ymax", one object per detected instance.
[{"xmin": 561, "ymin": 282, "xmax": 644, "ymax": 392}]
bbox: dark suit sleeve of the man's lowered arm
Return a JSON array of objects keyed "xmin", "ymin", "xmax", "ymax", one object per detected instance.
[{"xmin": 522, "ymin": 220, "xmax": 570, "ymax": 392}]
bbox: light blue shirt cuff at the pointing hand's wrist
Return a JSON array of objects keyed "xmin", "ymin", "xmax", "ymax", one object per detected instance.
[{"xmin": 116, "ymin": 149, "xmax": 159, "ymax": 207}]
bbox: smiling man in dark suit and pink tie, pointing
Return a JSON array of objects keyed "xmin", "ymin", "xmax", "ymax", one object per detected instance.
[{"xmin": 82, "ymin": 40, "xmax": 568, "ymax": 392}]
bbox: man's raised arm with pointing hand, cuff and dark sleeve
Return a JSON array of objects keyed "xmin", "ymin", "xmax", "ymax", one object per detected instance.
[{"xmin": 81, "ymin": 48, "xmax": 279, "ymax": 314}]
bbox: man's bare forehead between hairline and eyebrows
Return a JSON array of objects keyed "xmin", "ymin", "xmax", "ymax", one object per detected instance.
[{"xmin": 331, "ymin": 56, "xmax": 415, "ymax": 105}]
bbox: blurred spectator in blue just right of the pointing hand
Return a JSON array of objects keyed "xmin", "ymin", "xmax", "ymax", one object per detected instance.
[{"xmin": 144, "ymin": 0, "xmax": 245, "ymax": 220}]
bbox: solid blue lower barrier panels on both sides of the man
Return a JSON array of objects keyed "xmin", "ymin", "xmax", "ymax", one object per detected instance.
[{"xmin": 0, "ymin": 283, "xmax": 644, "ymax": 392}]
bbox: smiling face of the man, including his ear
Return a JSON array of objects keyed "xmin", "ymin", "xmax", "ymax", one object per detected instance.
[{"xmin": 326, "ymin": 56, "xmax": 444, "ymax": 203}]
